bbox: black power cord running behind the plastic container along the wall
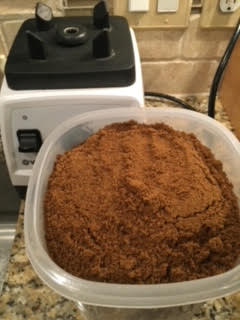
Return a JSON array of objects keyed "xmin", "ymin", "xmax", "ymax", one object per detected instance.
[{"xmin": 145, "ymin": 19, "xmax": 240, "ymax": 118}]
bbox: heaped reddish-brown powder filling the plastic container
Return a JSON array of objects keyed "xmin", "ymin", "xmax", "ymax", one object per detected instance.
[{"xmin": 45, "ymin": 121, "xmax": 240, "ymax": 283}]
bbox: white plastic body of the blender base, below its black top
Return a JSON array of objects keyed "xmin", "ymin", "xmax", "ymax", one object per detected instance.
[{"xmin": 0, "ymin": 30, "xmax": 144, "ymax": 186}]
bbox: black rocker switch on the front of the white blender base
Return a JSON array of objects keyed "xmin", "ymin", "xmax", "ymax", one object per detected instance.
[{"xmin": 17, "ymin": 129, "xmax": 42, "ymax": 153}]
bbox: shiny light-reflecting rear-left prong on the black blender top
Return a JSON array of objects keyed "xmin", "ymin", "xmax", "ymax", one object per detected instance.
[{"xmin": 35, "ymin": 2, "xmax": 53, "ymax": 31}]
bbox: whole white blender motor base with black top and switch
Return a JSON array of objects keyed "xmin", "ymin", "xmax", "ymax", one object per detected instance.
[{"xmin": 0, "ymin": 1, "xmax": 144, "ymax": 195}]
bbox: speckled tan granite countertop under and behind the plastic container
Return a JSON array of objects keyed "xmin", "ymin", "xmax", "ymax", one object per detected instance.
[{"xmin": 0, "ymin": 97, "xmax": 240, "ymax": 320}]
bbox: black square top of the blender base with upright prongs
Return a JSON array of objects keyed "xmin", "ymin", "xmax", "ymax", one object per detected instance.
[{"xmin": 5, "ymin": 1, "xmax": 135, "ymax": 90}]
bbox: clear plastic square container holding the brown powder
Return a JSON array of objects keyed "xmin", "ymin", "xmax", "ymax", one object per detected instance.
[{"xmin": 24, "ymin": 108, "xmax": 240, "ymax": 309}]
